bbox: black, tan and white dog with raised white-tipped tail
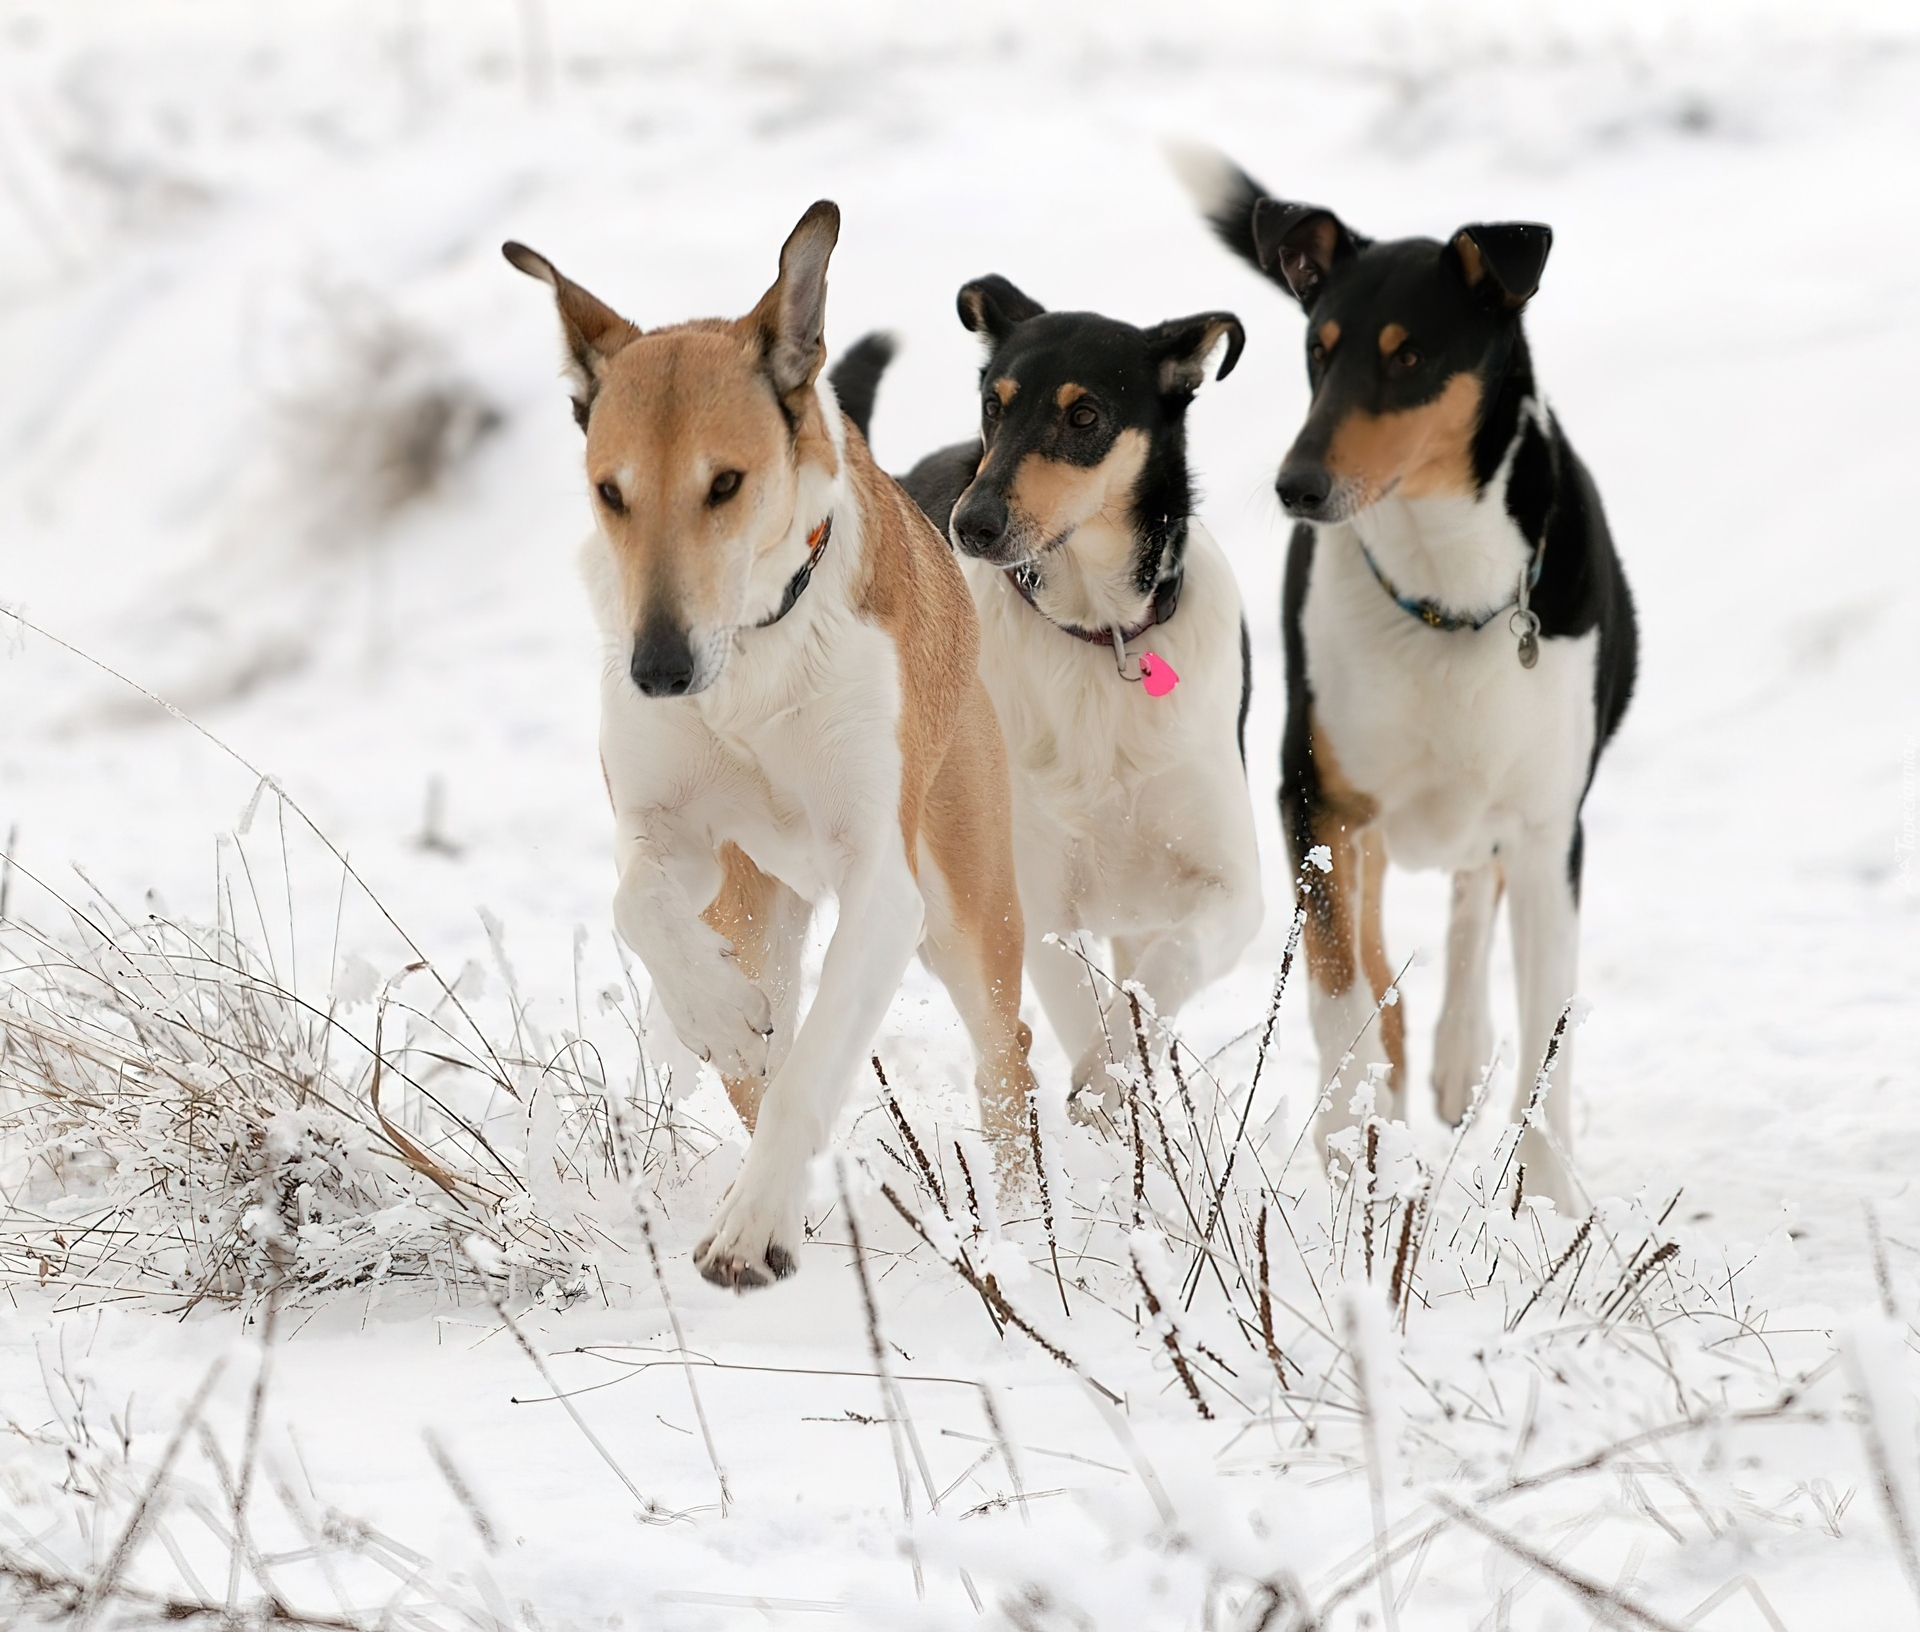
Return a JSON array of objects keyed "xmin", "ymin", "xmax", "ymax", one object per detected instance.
[{"xmin": 1175, "ymin": 150, "xmax": 1638, "ymax": 1210}]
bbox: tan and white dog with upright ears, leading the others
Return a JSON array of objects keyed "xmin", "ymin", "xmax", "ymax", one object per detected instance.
[{"xmin": 507, "ymin": 204, "xmax": 1033, "ymax": 1286}]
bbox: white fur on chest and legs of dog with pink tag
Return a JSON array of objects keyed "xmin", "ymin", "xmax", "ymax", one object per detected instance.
[{"xmin": 962, "ymin": 522, "xmax": 1261, "ymax": 1089}]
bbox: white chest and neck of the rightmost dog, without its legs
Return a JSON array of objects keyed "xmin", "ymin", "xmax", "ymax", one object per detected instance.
[{"xmin": 1302, "ymin": 513, "xmax": 1599, "ymax": 870}]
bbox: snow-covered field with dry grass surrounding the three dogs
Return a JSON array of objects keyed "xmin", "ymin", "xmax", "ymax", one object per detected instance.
[{"xmin": 0, "ymin": 0, "xmax": 1920, "ymax": 1632}]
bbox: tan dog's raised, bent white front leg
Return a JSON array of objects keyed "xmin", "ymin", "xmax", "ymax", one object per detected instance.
[{"xmin": 612, "ymin": 818, "xmax": 774, "ymax": 1081}]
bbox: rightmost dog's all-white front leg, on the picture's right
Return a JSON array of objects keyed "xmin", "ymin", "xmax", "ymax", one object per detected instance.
[{"xmin": 1501, "ymin": 839, "xmax": 1580, "ymax": 1213}]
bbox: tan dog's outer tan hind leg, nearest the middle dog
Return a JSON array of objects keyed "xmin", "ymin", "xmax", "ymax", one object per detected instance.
[{"xmin": 920, "ymin": 682, "xmax": 1033, "ymax": 1179}]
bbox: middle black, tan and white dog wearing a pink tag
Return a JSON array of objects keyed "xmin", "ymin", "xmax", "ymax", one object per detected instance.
[{"xmin": 835, "ymin": 276, "xmax": 1261, "ymax": 1116}]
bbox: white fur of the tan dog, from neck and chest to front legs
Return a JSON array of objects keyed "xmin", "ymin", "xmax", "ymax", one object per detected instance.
[{"xmin": 584, "ymin": 384, "xmax": 925, "ymax": 1267}]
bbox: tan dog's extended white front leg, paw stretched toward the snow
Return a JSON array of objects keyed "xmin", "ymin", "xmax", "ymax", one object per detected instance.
[{"xmin": 693, "ymin": 852, "xmax": 925, "ymax": 1288}]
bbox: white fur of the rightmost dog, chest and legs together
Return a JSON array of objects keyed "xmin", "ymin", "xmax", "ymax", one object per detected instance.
[{"xmin": 1300, "ymin": 482, "xmax": 1599, "ymax": 1208}]
